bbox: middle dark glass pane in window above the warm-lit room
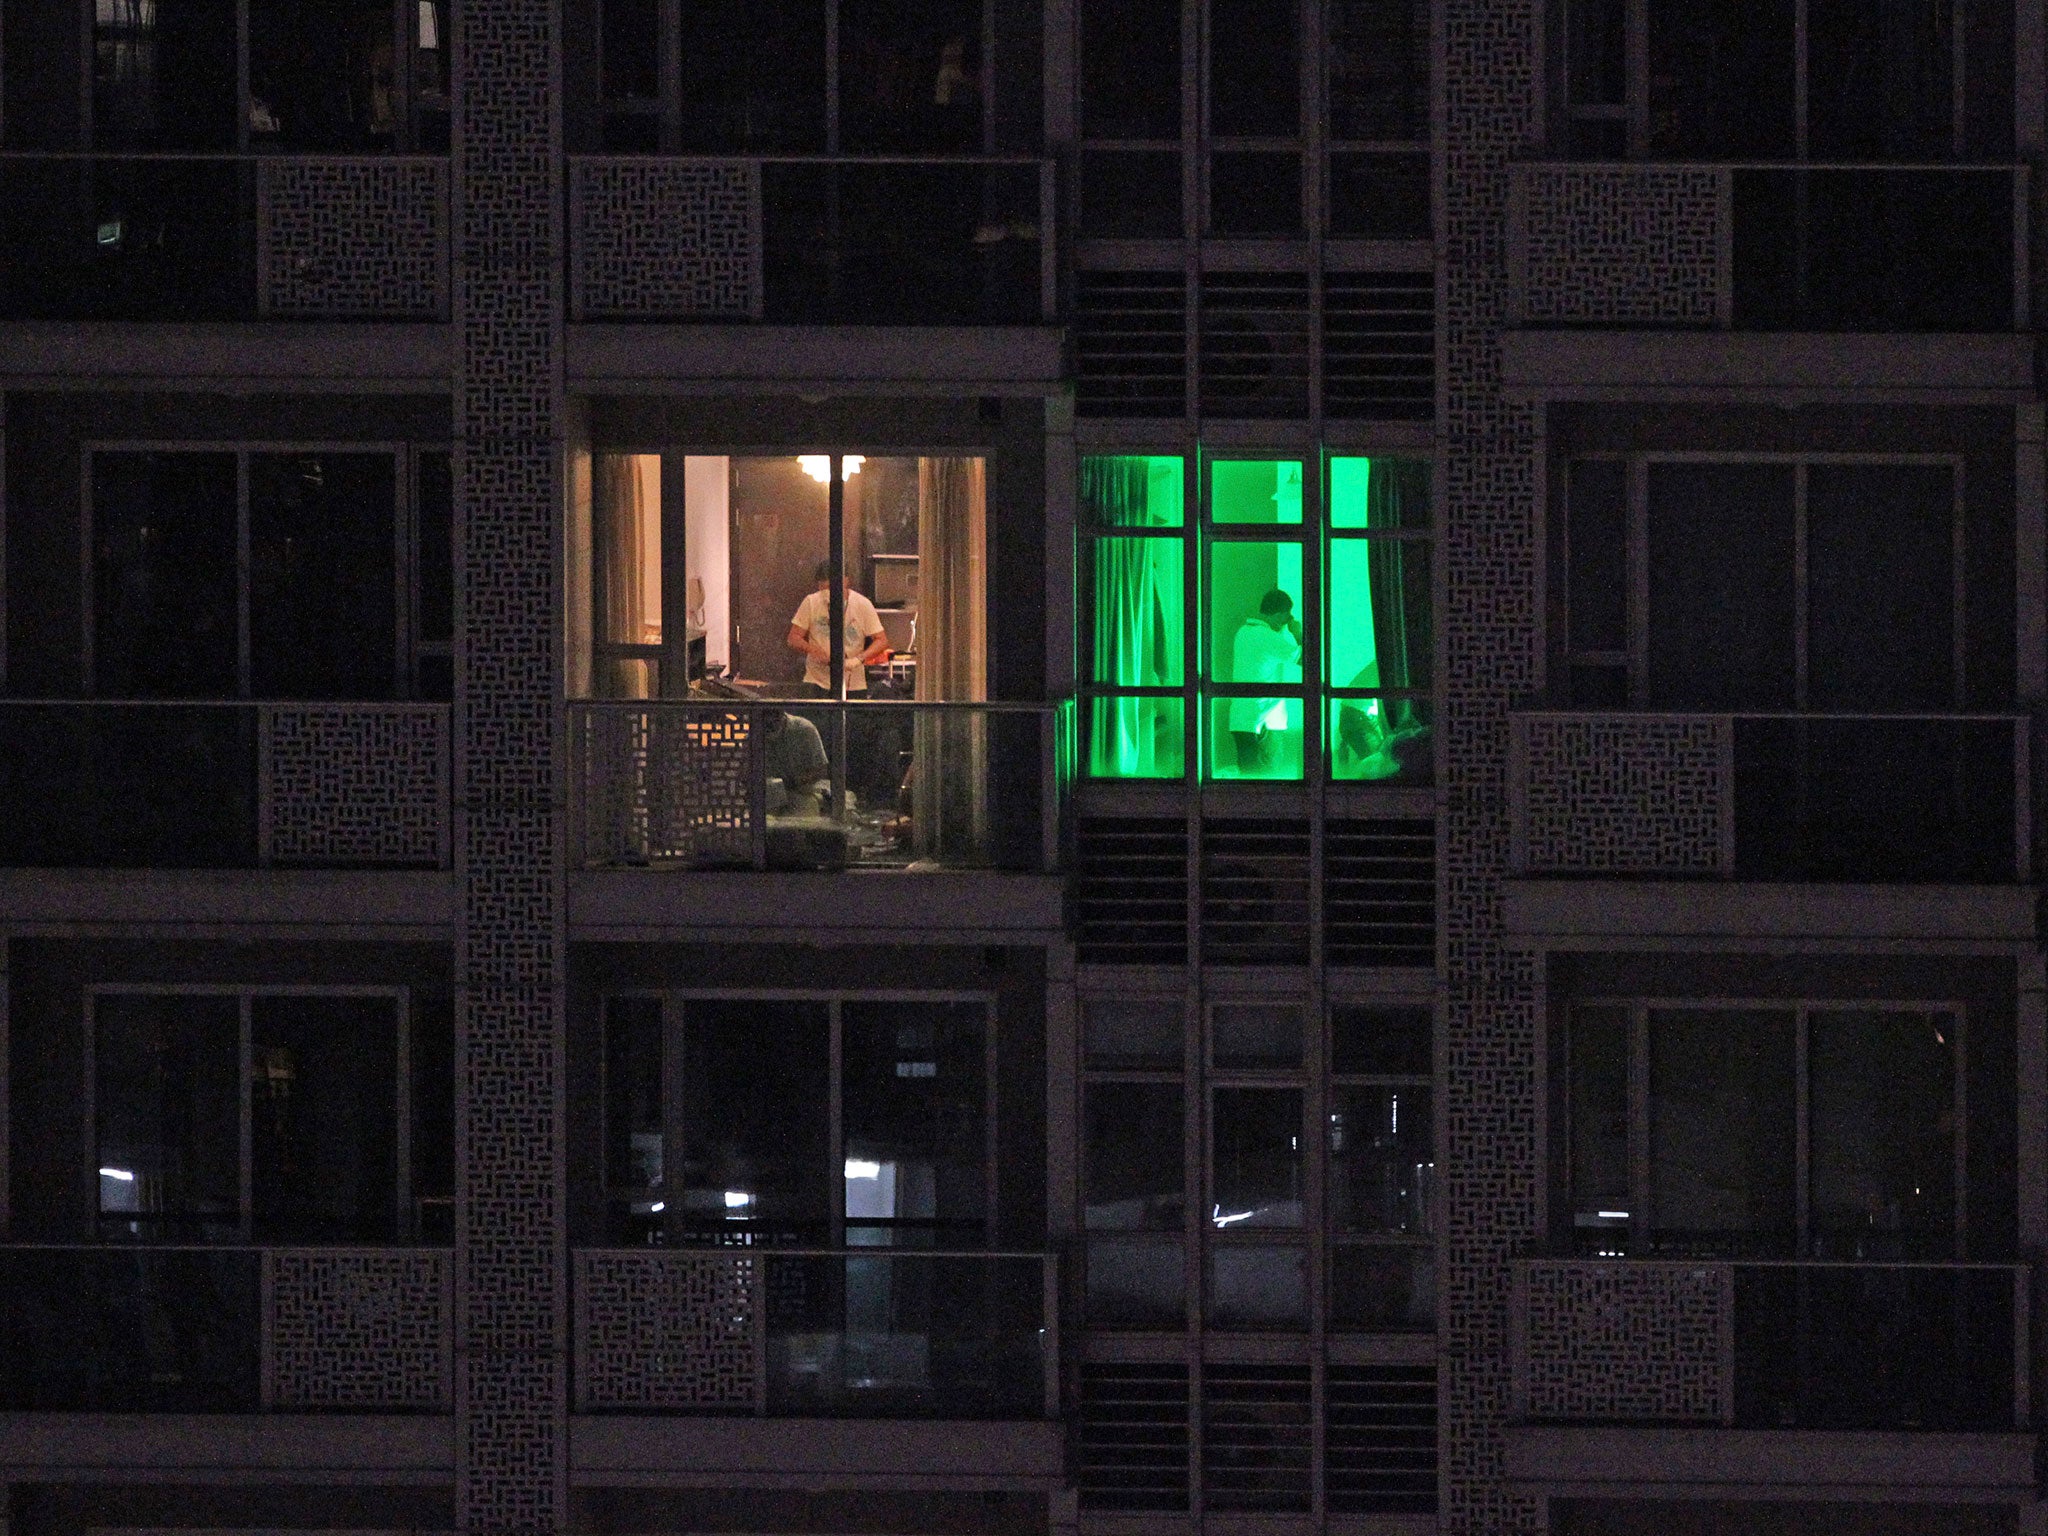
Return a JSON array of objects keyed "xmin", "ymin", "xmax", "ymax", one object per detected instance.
[{"xmin": 680, "ymin": 0, "xmax": 825, "ymax": 154}]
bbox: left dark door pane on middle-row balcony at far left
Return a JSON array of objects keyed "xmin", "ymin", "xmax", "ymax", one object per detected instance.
[{"xmin": 92, "ymin": 453, "xmax": 240, "ymax": 698}]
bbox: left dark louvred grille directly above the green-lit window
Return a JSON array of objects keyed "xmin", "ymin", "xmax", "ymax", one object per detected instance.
[{"xmin": 1073, "ymin": 272, "xmax": 1188, "ymax": 416}]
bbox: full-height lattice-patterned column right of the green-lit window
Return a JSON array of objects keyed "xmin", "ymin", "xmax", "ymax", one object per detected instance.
[{"xmin": 1436, "ymin": 0, "xmax": 1544, "ymax": 1536}]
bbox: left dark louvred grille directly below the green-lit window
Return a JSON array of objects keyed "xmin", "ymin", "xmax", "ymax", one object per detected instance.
[{"xmin": 1073, "ymin": 817, "xmax": 1188, "ymax": 965}]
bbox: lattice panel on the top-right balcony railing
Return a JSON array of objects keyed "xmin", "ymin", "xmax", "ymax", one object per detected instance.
[{"xmin": 1522, "ymin": 166, "xmax": 1726, "ymax": 326}]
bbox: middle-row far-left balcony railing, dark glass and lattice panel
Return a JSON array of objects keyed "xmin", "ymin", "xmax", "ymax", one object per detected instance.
[{"xmin": 0, "ymin": 698, "xmax": 449, "ymax": 868}]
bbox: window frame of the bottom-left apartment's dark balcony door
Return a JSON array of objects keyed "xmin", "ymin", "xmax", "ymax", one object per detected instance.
[{"xmin": 80, "ymin": 981, "xmax": 413, "ymax": 1247}]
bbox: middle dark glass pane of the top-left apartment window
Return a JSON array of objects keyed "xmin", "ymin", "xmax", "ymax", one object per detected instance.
[{"xmin": 250, "ymin": 0, "xmax": 397, "ymax": 154}]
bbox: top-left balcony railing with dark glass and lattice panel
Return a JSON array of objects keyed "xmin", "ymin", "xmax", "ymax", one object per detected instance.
[{"xmin": 0, "ymin": 154, "xmax": 449, "ymax": 319}]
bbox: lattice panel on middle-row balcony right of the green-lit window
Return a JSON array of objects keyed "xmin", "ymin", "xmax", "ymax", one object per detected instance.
[{"xmin": 1516, "ymin": 715, "xmax": 1735, "ymax": 874}]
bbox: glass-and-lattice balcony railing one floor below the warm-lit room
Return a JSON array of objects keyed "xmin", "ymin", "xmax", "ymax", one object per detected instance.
[{"xmin": 573, "ymin": 1247, "xmax": 1059, "ymax": 1419}]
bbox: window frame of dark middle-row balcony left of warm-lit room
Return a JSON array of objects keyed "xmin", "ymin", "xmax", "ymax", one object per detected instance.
[{"xmin": 78, "ymin": 438, "xmax": 436, "ymax": 702}]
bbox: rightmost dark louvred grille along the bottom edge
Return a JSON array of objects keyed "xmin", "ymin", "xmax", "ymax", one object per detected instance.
[{"xmin": 1323, "ymin": 1366, "xmax": 1436, "ymax": 1516}]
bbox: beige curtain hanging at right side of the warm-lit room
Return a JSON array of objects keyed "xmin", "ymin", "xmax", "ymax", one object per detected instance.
[{"xmin": 911, "ymin": 459, "xmax": 989, "ymax": 862}]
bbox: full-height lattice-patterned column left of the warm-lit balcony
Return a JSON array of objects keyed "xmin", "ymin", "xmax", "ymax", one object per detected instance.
[{"xmin": 453, "ymin": 0, "xmax": 567, "ymax": 1532}]
